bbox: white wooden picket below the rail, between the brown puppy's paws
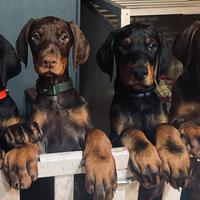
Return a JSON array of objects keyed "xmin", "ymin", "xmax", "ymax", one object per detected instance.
[{"xmin": 54, "ymin": 175, "xmax": 74, "ymax": 200}]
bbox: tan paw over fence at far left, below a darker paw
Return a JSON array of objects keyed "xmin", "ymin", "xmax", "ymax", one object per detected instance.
[{"xmin": 3, "ymin": 143, "xmax": 39, "ymax": 190}]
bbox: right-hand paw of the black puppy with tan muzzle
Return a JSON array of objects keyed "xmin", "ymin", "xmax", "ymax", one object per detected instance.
[{"xmin": 156, "ymin": 125, "xmax": 190, "ymax": 189}]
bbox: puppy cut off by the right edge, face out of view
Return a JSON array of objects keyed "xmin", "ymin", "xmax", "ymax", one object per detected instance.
[{"xmin": 170, "ymin": 21, "xmax": 200, "ymax": 200}]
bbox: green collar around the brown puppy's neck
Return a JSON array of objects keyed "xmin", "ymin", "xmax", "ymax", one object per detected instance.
[{"xmin": 37, "ymin": 79, "xmax": 73, "ymax": 96}]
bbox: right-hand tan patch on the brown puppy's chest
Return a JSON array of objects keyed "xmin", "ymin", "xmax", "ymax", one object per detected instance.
[{"xmin": 69, "ymin": 107, "xmax": 89, "ymax": 126}]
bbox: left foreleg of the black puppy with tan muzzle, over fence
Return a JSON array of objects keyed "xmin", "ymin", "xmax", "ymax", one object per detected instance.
[{"xmin": 122, "ymin": 129, "xmax": 161, "ymax": 189}]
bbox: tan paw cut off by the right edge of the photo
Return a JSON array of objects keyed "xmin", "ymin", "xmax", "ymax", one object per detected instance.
[{"xmin": 179, "ymin": 122, "xmax": 200, "ymax": 157}]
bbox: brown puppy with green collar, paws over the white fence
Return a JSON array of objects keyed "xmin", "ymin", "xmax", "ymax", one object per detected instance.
[{"xmin": 1, "ymin": 16, "xmax": 116, "ymax": 200}]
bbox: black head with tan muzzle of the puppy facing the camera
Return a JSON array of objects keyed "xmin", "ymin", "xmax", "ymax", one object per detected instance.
[{"xmin": 97, "ymin": 23, "xmax": 172, "ymax": 90}]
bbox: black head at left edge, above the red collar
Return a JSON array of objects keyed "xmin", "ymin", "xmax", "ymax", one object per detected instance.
[{"xmin": 0, "ymin": 35, "xmax": 21, "ymax": 88}]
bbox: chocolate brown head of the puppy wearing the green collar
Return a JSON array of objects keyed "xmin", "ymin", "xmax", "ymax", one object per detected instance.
[{"xmin": 16, "ymin": 16, "xmax": 90, "ymax": 77}]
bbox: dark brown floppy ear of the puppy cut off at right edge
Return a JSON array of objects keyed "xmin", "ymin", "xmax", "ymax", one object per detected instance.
[{"xmin": 173, "ymin": 21, "xmax": 200, "ymax": 69}]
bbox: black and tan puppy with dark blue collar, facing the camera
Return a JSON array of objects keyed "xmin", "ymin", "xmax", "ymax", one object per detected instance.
[{"xmin": 97, "ymin": 23, "xmax": 189, "ymax": 199}]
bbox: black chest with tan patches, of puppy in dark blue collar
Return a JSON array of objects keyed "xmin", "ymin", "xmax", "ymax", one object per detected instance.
[{"xmin": 111, "ymin": 96, "xmax": 168, "ymax": 140}]
